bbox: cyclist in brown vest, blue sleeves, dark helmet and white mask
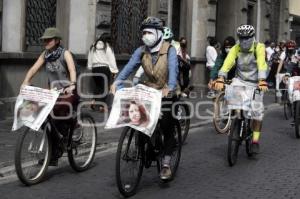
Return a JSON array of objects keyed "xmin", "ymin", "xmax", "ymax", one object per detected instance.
[{"xmin": 111, "ymin": 17, "xmax": 178, "ymax": 180}]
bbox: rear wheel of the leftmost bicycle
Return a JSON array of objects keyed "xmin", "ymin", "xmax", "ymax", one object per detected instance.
[{"xmin": 68, "ymin": 114, "xmax": 97, "ymax": 172}]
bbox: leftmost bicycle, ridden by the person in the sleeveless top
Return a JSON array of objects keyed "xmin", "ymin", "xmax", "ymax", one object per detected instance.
[{"xmin": 15, "ymin": 88, "xmax": 97, "ymax": 186}]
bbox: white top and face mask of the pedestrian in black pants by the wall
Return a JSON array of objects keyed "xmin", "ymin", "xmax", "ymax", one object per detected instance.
[{"xmin": 87, "ymin": 41, "xmax": 119, "ymax": 73}]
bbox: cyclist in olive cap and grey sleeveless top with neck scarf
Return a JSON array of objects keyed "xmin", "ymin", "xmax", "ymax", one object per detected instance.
[{"xmin": 22, "ymin": 27, "xmax": 79, "ymax": 166}]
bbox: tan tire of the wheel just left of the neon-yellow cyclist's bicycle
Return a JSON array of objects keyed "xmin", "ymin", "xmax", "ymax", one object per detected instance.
[{"xmin": 213, "ymin": 92, "xmax": 231, "ymax": 134}]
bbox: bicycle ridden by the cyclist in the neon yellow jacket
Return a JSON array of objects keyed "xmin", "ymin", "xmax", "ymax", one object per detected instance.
[{"xmin": 226, "ymin": 85, "xmax": 260, "ymax": 166}]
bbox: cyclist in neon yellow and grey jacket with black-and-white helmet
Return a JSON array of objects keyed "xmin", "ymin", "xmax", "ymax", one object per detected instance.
[{"xmin": 215, "ymin": 25, "xmax": 268, "ymax": 153}]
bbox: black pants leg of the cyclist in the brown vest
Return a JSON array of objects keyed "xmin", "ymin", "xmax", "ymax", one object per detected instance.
[{"xmin": 160, "ymin": 97, "xmax": 177, "ymax": 155}]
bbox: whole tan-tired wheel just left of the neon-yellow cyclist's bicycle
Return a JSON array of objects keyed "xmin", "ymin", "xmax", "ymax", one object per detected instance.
[{"xmin": 213, "ymin": 92, "xmax": 231, "ymax": 134}]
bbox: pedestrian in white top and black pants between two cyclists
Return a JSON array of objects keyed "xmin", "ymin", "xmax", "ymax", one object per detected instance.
[{"xmin": 87, "ymin": 33, "xmax": 119, "ymax": 112}]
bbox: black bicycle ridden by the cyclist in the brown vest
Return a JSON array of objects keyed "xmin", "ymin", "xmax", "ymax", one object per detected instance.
[{"xmin": 116, "ymin": 117, "xmax": 182, "ymax": 197}]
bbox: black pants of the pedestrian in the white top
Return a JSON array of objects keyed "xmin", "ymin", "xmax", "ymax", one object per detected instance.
[{"xmin": 92, "ymin": 66, "xmax": 112, "ymax": 109}]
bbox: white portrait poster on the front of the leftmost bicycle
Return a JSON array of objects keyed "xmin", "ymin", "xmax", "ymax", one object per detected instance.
[{"xmin": 12, "ymin": 86, "xmax": 59, "ymax": 131}]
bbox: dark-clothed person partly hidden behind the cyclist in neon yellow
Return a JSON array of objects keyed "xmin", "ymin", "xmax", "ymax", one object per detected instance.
[{"xmin": 208, "ymin": 36, "xmax": 235, "ymax": 89}]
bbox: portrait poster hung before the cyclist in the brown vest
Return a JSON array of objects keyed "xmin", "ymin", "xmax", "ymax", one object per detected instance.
[{"xmin": 105, "ymin": 84, "xmax": 162, "ymax": 137}]
